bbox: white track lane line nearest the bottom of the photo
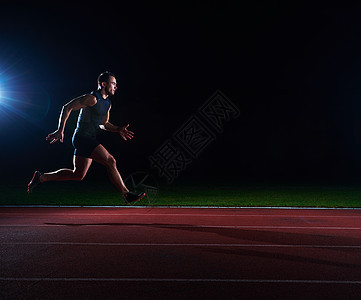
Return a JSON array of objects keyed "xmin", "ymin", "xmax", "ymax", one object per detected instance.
[{"xmin": 0, "ymin": 277, "xmax": 361, "ymax": 284}]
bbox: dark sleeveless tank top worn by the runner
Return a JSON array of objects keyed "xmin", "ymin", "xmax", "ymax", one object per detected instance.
[{"xmin": 74, "ymin": 91, "xmax": 111, "ymax": 137}]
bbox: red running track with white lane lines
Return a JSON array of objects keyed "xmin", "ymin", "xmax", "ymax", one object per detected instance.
[{"xmin": 0, "ymin": 207, "xmax": 361, "ymax": 300}]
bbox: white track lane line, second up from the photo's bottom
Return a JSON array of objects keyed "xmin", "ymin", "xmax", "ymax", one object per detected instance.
[{"xmin": 0, "ymin": 242, "xmax": 361, "ymax": 249}]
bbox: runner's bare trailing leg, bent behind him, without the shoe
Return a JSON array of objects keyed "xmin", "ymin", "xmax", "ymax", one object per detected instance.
[{"xmin": 40, "ymin": 155, "xmax": 93, "ymax": 182}]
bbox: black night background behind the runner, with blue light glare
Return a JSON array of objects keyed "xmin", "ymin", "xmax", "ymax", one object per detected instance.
[{"xmin": 0, "ymin": 0, "xmax": 361, "ymax": 182}]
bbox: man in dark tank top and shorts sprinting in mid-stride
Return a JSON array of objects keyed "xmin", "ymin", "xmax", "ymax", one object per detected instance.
[{"xmin": 28, "ymin": 72, "xmax": 145, "ymax": 203}]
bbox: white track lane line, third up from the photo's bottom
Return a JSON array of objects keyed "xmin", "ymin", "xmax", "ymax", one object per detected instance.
[{"xmin": 0, "ymin": 223, "xmax": 361, "ymax": 230}]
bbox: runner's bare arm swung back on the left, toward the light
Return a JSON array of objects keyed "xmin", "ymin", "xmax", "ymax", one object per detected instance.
[{"xmin": 46, "ymin": 94, "xmax": 97, "ymax": 144}]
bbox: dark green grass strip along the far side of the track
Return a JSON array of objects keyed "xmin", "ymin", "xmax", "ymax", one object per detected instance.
[{"xmin": 0, "ymin": 181, "xmax": 361, "ymax": 208}]
